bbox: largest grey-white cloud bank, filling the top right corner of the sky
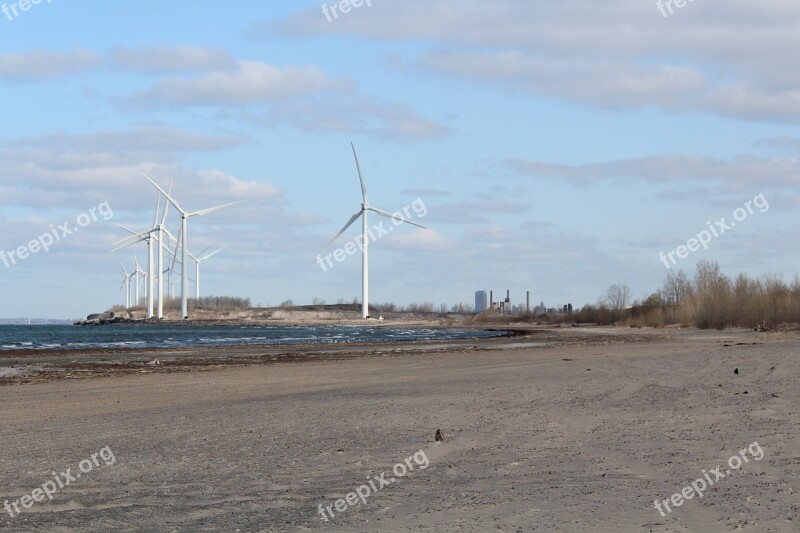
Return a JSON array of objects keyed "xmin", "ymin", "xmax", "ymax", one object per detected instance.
[{"xmin": 282, "ymin": 0, "xmax": 800, "ymax": 122}]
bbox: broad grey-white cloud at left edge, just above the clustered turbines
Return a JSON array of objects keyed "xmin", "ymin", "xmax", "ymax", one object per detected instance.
[{"xmin": 0, "ymin": 125, "xmax": 258, "ymax": 209}]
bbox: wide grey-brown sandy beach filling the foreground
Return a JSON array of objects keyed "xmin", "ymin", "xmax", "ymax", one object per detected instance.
[{"xmin": 0, "ymin": 328, "xmax": 800, "ymax": 532}]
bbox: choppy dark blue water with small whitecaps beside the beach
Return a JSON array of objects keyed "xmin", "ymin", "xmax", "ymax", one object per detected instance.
[{"xmin": 0, "ymin": 325, "xmax": 502, "ymax": 350}]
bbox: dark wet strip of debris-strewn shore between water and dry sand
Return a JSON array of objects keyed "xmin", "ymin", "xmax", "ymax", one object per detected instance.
[{"xmin": 0, "ymin": 326, "xmax": 724, "ymax": 387}]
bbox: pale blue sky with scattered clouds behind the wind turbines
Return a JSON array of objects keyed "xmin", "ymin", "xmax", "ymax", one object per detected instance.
[{"xmin": 0, "ymin": 0, "xmax": 800, "ymax": 318}]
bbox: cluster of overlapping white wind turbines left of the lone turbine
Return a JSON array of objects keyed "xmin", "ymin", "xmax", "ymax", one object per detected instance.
[{"xmin": 112, "ymin": 172, "xmax": 240, "ymax": 319}]
